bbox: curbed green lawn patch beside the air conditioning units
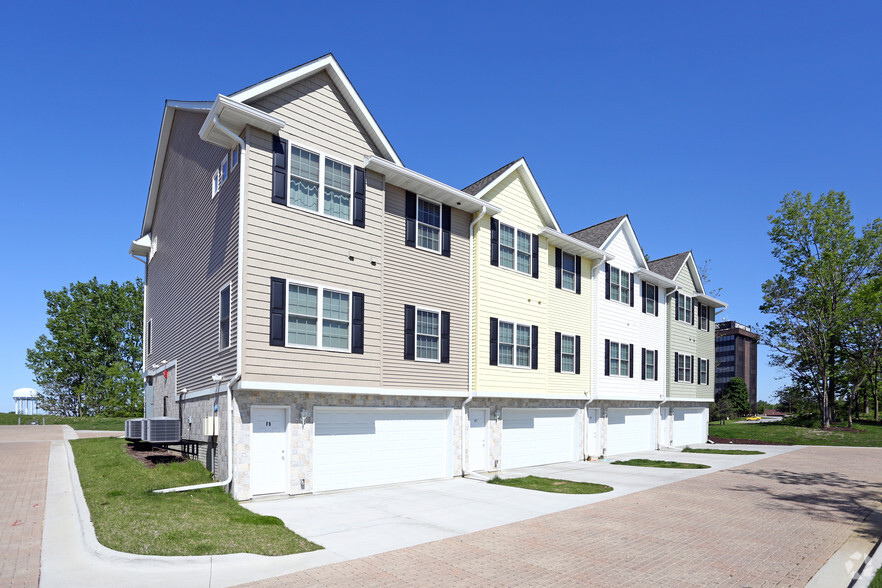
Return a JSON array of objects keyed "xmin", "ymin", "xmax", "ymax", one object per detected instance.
[{"xmin": 71, "ymin": 438, "xmax": 321, "ymax": 555}]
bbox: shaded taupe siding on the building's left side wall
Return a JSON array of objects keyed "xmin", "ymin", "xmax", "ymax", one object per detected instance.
[{"xmin": 145, "ymin": 110, "xmax": 241, "ymax": 396}]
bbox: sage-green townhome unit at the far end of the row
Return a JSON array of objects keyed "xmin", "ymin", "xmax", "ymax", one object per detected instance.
[{"xmin": 649, "ymin": 251, "xmax": 726, "ymax": 445}]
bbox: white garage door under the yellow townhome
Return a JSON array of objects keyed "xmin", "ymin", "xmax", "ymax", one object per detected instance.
[{"xmin": 501, "ymin": 408, "xmax": 578, "ymax": 469}]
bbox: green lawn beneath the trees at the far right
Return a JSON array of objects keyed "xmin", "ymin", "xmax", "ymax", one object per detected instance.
[{"xmin": 708, "ymin": 421, "xmax": 882, "ymax": 447}]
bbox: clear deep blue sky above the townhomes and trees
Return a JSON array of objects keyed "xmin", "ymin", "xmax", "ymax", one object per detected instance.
[{"xmin": 0, "ymin": 1, "xmax": 882, "ymax": 411}]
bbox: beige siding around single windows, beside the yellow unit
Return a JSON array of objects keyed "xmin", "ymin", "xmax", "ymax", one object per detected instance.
[{"xmin": 383, "ymin": 184, "xmax": 472, "ymax": 391}]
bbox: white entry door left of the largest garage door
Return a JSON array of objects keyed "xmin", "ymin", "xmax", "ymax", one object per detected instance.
[{"xmin": 251, "ymin": 406, "xmax": 288, "ymax": 495}]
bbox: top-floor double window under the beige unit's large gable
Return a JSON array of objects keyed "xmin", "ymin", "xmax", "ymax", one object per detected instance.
[{"xmin": 288, "ymin": 145, "xmax": 352, "ymax": 222}]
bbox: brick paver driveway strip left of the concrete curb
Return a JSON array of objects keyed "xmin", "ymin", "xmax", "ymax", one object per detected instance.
[{"xmin": 0, "ymin": 425, "xmax": 64, "ymax": 586}]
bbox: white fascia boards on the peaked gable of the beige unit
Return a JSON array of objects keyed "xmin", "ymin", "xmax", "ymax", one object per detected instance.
[{"xmin": 230, "ymin": 53, "xmax": 403, "ymax": 165}]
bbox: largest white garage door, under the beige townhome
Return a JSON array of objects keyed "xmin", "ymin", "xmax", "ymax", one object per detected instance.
[{"xmin": 313, "ymin": 407, "xmax": 452, "ymax": 492}]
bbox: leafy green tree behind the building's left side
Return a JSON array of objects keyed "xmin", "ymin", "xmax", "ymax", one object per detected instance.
[{"xmin": 26, "ymin": 278, "xmax": 144, "ymax": 416}]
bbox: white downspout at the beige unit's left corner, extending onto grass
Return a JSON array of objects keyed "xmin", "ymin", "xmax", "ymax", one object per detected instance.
[{"xmin": 155, "ymin": 115, "xmax": 247, "ymax": 494}]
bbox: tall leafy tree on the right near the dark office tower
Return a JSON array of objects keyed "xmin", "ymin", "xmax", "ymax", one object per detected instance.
[{"xmin": 760, "ymin": 191, "xmax": 882, "ymax": 427}]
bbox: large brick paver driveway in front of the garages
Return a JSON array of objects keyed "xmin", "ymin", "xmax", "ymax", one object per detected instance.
[{"xmin": 241, "ymin": 447, "xmax": 882, "ymax": 587}]
